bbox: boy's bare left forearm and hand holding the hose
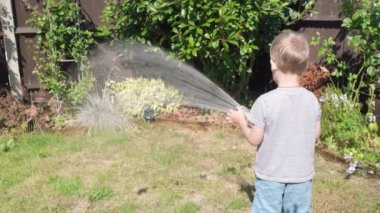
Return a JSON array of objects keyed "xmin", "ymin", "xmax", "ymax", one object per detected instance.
[{"xmin": 227, "ymin": 108, "xmax": 264, "ymax": 146}]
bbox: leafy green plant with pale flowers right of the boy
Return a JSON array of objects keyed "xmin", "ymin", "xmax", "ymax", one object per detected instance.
[{"xmin": 320, "ymin": 85, "xmax": 380, "ymax": 163}]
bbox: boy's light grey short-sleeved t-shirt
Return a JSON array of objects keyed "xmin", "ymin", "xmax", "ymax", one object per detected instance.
[{"xmin": 248, "ymin": 87, "xmax": 321, "ymax": 183}]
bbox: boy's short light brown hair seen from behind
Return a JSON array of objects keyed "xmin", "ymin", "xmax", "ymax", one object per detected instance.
[{"xmin": 270, "ymin": 31, "xmax": 310, "ymax": 74}]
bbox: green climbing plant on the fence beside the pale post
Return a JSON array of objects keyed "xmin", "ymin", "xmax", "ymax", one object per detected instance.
[{"xmin": 29, "ymin": 0, "xmax": 94, "ymax": 104}]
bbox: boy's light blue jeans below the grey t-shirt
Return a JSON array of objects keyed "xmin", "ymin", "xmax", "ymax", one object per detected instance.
[{"xmin": 252, "ymin": 178, "xmax": 312, "ymax": 213}]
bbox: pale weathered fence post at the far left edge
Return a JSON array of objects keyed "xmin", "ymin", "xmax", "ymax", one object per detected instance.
[{"xmin": 0, "ymin": 0, "xmax": 22, "ymax": 101}]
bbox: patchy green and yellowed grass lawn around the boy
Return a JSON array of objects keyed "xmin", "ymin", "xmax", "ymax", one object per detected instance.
[{"xmin": 0, "ymin": 122, "xmax": 380, "ymax": 213}]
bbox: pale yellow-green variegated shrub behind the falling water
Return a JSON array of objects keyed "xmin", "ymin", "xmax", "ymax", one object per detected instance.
[{"xmin": 106, "ymin": 77, "xmax": 182, "ymax": 117}]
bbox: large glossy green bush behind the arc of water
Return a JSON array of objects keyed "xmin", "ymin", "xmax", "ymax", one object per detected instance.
[{"xmin": 101, "ymin": 0, "xmax": 314, "ymax": 102}]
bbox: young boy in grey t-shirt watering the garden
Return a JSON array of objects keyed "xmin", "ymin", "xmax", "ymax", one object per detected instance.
[{"xmin": 227, "ymin": 31, "xmax": 321, "ymax": 213}]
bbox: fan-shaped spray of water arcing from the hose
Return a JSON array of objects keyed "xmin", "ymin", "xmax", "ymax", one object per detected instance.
[{"xmin": 91, "ymin": 42, "xmax": 239, "ymax": 112}]
